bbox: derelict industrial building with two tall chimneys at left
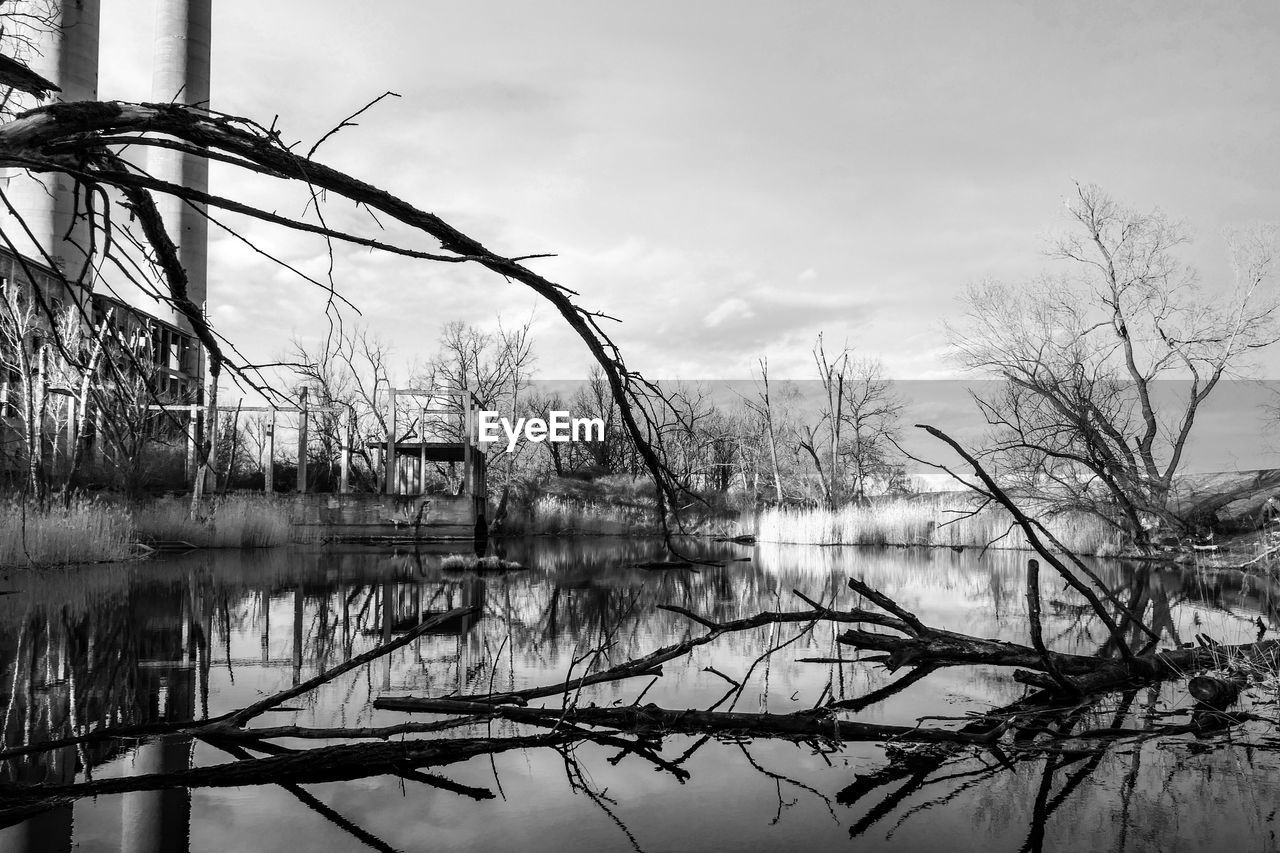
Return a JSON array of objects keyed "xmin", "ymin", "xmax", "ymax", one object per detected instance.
[{"xmin": 0, "ymin": 0, "xmax": 211, "ymax": 475}]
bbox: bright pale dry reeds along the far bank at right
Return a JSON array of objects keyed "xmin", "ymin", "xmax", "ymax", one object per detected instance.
[{"xmin": 755, "ymin": 496, "xmax": 1121, "ymax": 556}]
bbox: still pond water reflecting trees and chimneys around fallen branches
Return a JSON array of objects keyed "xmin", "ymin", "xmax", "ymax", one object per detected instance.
[{"xmin": 0, "ymin": 539, "xmax": 1280, "ymax": 853}]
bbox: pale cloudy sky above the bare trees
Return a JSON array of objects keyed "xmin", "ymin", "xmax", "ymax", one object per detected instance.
[{"xmin": 100, "ymin": 0, "xmax": 1280, "ymax": 379}]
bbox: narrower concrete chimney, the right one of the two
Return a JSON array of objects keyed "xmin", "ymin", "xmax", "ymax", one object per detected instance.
[{"xmin": 147, "ymin": 0, "xmax": 212, "ymax": 332}]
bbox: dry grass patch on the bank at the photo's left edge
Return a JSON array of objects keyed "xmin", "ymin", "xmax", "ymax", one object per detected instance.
[{"xmin": 0, "ymin": 498, "xmax": 137, "ymax": 566}]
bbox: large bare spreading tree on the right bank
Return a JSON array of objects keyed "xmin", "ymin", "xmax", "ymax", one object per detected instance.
[{"xmin": 950, "ymin": 186, "xmax": 1280, "ymax": 544}]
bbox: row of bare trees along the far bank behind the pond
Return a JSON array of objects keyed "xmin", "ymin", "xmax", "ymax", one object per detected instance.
[{"xmin": 282, "ymin": 323, "xmax": 908, "ymax": 507}]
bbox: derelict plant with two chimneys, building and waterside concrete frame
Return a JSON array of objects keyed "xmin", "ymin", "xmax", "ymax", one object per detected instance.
[{"xmin": 0, "ymin": 0, "xmax": 486, "ymax": 538}]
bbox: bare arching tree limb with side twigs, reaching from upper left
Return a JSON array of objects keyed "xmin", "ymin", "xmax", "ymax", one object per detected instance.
[{"xmin": 0, "ymin": 33, "xmax": 706, "ymax": 532}]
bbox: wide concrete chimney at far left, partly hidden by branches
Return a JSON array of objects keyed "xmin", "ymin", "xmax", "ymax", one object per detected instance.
[{"xmin": 0, "ymin": 0, "xmax": 100, "ymax": 274}]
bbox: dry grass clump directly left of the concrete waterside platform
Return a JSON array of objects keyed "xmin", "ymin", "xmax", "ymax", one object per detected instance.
[{"xmin": 134, "ymin": 496, "xmax": 291, "ymax": 548}]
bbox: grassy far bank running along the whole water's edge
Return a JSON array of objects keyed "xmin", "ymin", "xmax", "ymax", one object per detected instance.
[{"xmin": 0, "ymin": 475, "xmax": 1280, "ymax": 571}]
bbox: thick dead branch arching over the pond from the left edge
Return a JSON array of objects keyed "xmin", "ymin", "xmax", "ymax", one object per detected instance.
[{"xmin": 0, "ymin": 101, "xmax": 706, "ymax": 525}]
